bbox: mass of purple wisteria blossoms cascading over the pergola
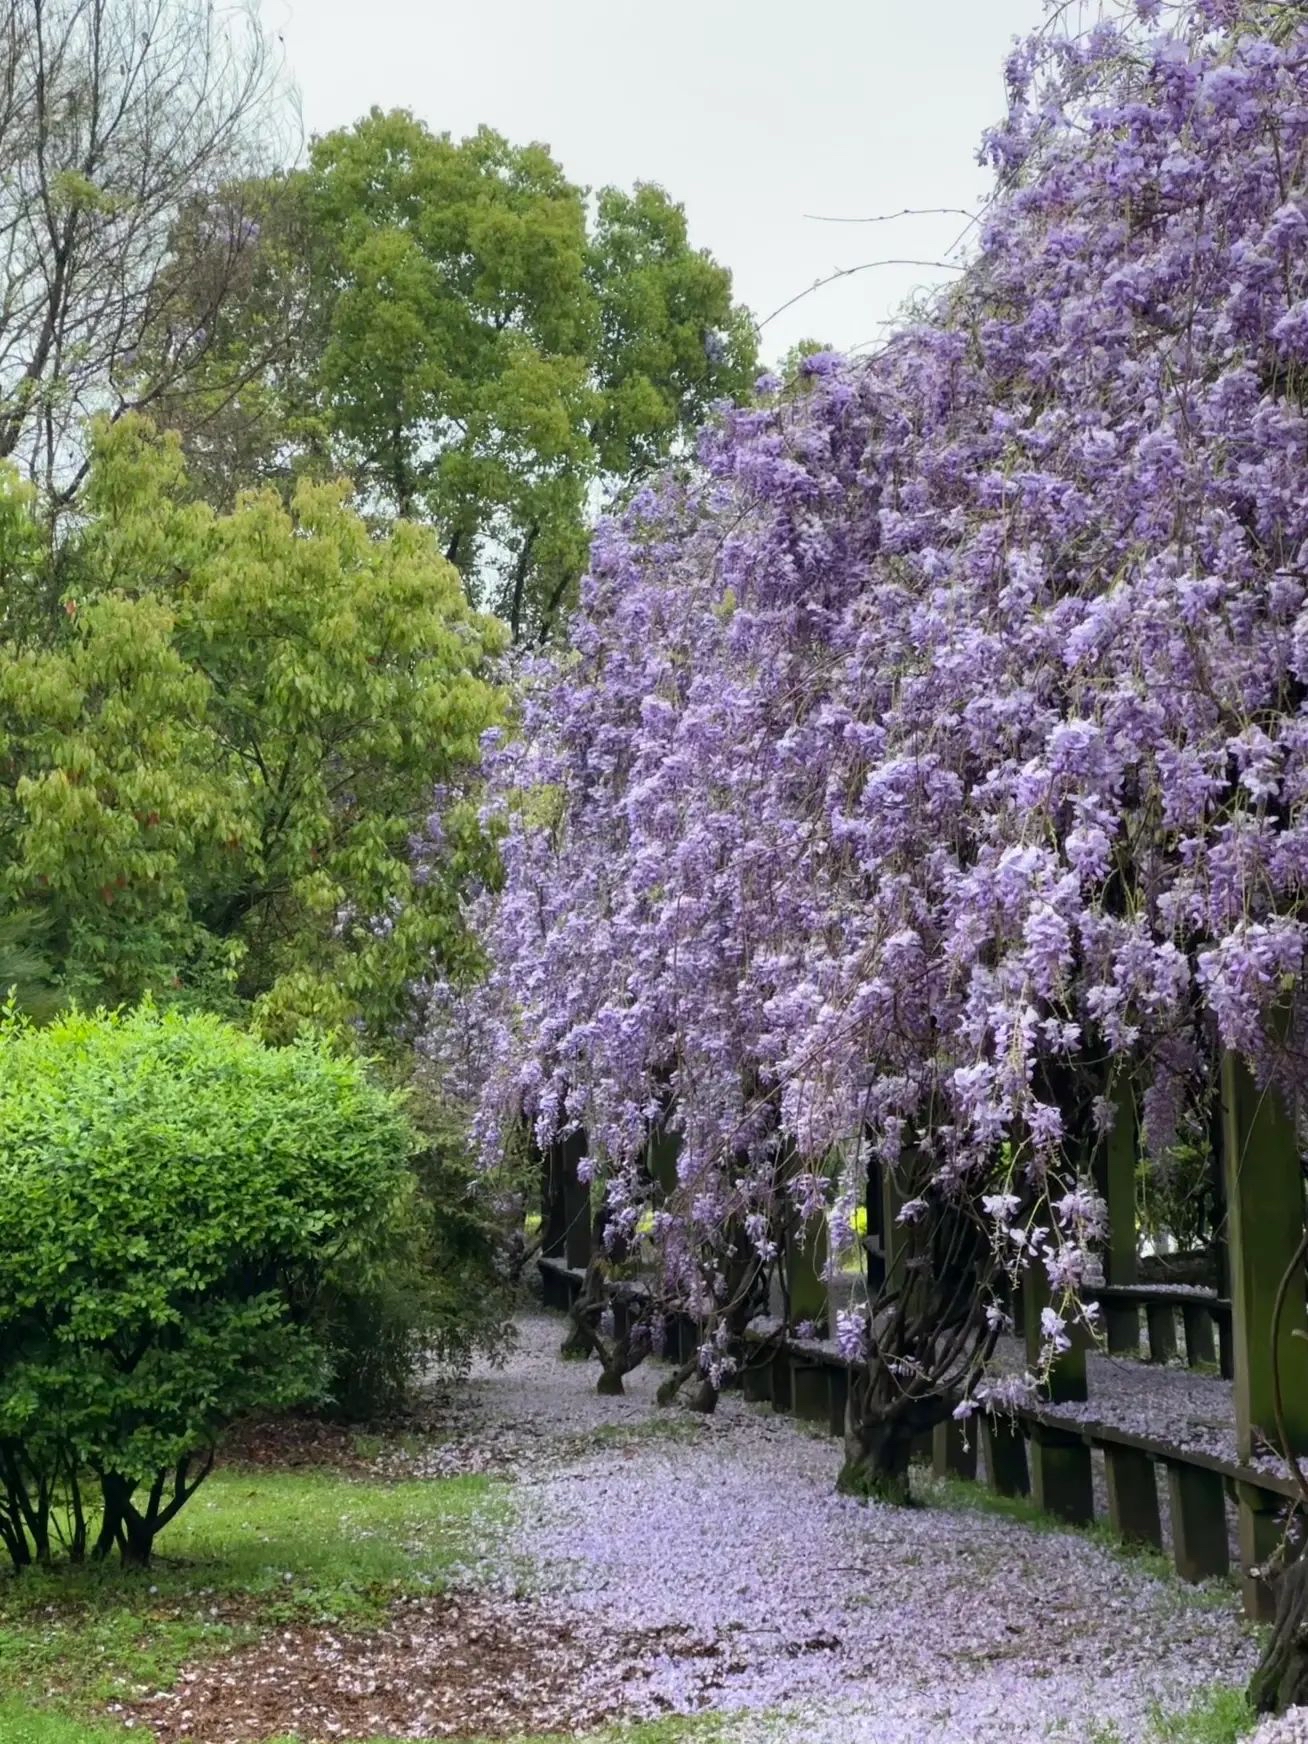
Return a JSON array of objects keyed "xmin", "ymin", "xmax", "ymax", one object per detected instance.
[{"xmin": 436, "ymin": 0, "xmax": 1308, "ymax": 1341}]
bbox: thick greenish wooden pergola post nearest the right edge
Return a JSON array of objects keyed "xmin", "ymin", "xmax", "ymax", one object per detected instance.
[{"xmin": 1221, "ymin": 1052, "xmax": 1308, "ymax": 1615}]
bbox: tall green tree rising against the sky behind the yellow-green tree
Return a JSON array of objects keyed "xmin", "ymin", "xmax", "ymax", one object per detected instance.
[{"xmin": 167, "ymin": 110, "xmax": 755, "ymax": 638}]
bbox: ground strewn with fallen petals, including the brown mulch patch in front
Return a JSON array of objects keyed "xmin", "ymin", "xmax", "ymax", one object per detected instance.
[{"xmin": 129, "ymin": 1315, "xmax": 1262, "ymax": 1744}]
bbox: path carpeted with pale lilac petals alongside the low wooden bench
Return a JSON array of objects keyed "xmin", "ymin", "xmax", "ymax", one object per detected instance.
[{"xmin": 449, "ymin": 1315, "xmax": 1254, "ymax": 1744}]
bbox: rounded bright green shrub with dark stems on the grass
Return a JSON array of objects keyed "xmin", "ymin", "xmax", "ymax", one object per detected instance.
[{"xmin": 0, "ymin": 1006, "xmax": 413, "ymax": 1566}]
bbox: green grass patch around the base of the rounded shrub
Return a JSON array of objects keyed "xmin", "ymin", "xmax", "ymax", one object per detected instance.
[{"xmin": 0, "ymin": 1472, "xmax": 508, "ymax": 1716}]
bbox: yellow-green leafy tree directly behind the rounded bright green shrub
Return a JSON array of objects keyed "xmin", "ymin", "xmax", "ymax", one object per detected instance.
[{"xmin": 0, "ymin": 417, "xmax": 502, "ymax": 1036}]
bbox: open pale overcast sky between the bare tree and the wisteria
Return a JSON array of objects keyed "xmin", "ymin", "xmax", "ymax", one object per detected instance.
[{"xmin": 272, "ymin": 0, "xmax": 1043, "ymax": 359}]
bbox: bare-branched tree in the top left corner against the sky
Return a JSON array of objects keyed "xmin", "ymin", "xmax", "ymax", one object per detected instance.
[{"xmin": 0, "ymin": 0, "xmax": 293, "ymax": 514}]
